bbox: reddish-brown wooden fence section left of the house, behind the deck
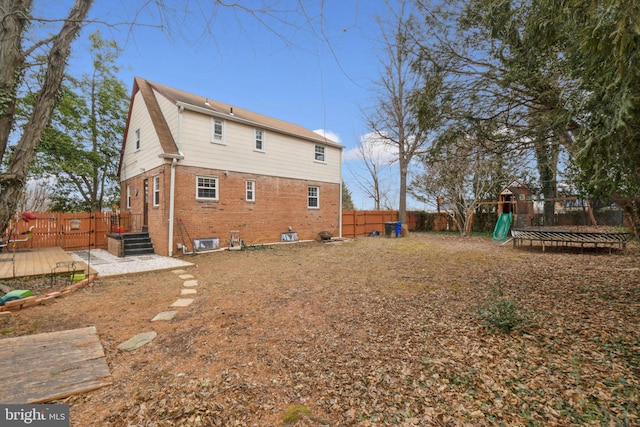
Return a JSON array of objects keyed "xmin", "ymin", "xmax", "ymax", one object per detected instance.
[{"xmin": 3, "ymin": 212, "xmax": 140, "ymax": 250}]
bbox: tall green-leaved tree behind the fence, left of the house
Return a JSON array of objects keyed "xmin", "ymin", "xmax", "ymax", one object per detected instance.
[{"xmin": 37, "ymin": 32, "xmax": 128, "ymax": 212}]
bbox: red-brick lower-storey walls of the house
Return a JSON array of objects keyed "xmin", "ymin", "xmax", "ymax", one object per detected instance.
[{"xmin": 122, "ymin": 165, "xmax": 340, "ymax": 255}]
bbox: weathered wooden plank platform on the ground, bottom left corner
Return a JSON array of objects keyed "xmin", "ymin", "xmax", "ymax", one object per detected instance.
[{"xmin": 0, "ymin": 326, "xmax": 112, "ymax": 404}]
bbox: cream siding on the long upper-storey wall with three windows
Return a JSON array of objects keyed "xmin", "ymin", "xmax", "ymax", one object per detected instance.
[{"xmin": 180, "ymin": 110, "xmax": 342, "ymax": 183}]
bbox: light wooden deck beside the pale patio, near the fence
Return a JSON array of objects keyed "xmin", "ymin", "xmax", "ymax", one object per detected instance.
[{"xmin": 0, "ymin": 247, "xmax": 96, "ymax": 280}]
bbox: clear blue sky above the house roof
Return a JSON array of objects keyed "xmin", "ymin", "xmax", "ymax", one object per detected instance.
[{"xmin": 36, "ymin": 0, "xmax": 421, "ymax": 209}]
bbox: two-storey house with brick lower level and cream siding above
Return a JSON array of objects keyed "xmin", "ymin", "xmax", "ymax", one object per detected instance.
[{"xmin": 119, "ymin": 77, "xmax": 343, "ymax": 256}]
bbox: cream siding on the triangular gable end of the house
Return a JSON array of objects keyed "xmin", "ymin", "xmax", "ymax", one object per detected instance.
[{"xmin": 120, "ymin": 92, "xmax": 163, "ymax": 181}]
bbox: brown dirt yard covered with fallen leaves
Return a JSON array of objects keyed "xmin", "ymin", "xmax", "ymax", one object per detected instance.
[{"xmin": 0, "ymin": 233, "xmax": 640, "ymax": 427}]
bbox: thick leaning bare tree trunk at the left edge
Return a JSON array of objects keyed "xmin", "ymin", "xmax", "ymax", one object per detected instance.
[{"xmin": 0, "ymin": 0, "xmax": 93, "ymax": 230}]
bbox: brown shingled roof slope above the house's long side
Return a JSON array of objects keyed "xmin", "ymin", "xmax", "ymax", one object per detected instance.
[{"xmin": 135, "ymin": 77, "xmax": 342, "ymax": 148}]
